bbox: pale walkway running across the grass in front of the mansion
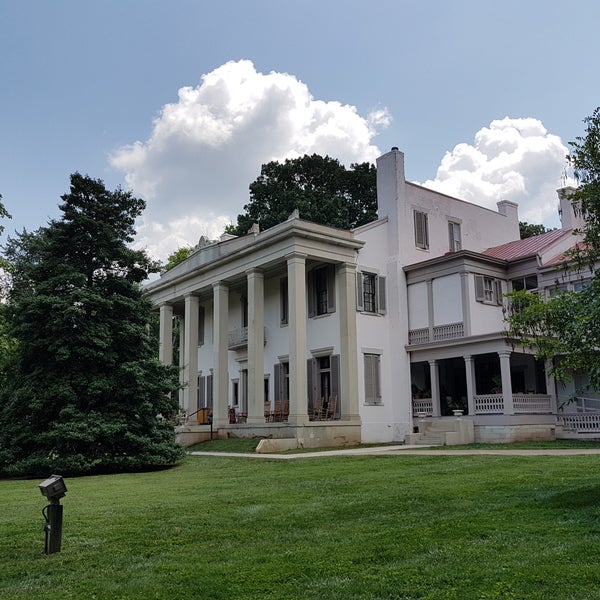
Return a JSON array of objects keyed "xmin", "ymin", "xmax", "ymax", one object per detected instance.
[{"xmin": 189, "ymin": 445, "xmax": 600, "ymax": 460}]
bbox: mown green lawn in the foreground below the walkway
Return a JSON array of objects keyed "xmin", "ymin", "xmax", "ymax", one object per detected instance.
[{"xmin": 0, "ymin": 455, "xmax": 600, "ymax": 600}]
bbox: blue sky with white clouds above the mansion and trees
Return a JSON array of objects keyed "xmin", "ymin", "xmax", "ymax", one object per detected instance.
[{"xmin": 0, "ymin": 0, "xmax": 600, "ymax": 258}]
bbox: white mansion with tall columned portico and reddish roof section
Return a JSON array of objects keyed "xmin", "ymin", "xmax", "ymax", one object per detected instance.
[{"xmin": 147, "ymin": 148, "xmax": 593, "ymax": 448}]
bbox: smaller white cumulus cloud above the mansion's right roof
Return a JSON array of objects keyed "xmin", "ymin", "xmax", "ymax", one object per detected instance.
[{"xmin": 422, "ymin": 117, "xmax": 574, "ymax": 227}]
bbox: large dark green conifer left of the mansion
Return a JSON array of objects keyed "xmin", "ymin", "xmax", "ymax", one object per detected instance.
[{"xmin": 0, "ymin": 173, "xmax": 182, "ymax": 476}]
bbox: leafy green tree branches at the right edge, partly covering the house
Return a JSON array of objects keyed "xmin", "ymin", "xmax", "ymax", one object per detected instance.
[{"xmin": 508, "ymin": 107, "xmax": 600, "ymax": 389}]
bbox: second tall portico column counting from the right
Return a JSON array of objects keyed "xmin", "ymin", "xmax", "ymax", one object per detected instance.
[{"xmin": 286, "ymin": 252, "xmax": 308, "ymax": 425}]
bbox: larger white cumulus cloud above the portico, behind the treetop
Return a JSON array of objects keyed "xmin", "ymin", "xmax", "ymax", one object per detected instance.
[{"xmin": 110, "ymin": 60, "xmax": 390, "ymax": 260}]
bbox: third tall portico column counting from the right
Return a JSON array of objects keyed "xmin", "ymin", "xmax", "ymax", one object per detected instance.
[{"xmin": 246, "ymin": 269, "xmax": 265, "ymax": 423}]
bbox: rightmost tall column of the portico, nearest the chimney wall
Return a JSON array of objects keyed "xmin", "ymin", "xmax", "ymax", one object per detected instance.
[{"xmin": 337, "ymin": 263, "xmax": 360, "ymax": 421}]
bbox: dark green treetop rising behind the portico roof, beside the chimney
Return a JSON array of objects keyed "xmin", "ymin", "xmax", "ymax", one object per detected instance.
[{"xmin": 227, "ymin": 154, "xmax": 377, "ymax": 235}]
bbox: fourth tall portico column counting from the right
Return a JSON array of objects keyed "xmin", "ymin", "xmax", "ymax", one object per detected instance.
[{"xmin": 213, "ymin": 281, "xmax": 229, "ymax": 427}]
